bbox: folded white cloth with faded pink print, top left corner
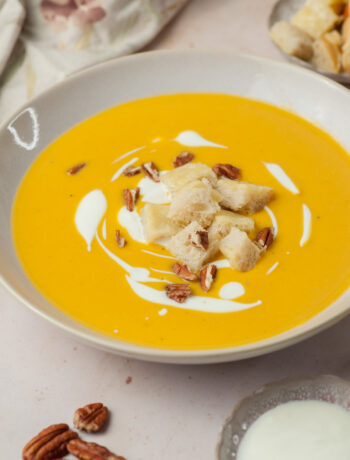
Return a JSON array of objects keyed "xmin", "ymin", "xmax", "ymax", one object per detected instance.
[{"xmin": 0, "ymin": 0, "xmax": 187, "ymax": 122}]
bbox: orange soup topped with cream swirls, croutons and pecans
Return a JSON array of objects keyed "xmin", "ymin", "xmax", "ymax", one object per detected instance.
[{"xmin": 12, "ymin": 94, "xmax": 350, "ymax": 350}]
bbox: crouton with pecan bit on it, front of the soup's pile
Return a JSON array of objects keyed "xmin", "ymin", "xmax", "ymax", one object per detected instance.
[{"xmin": 169, "ymin": 222, "xmax": 219, "ymax": 272}]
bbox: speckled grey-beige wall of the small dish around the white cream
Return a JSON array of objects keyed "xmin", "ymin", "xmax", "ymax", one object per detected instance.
[{"xmin": 217, "ymin": 375, "xmax": 350, "ymax": 460}]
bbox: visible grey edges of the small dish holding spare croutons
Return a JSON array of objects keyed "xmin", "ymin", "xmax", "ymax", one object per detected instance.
[{"xmin": 268, "ymin": 0, "xmax": 350, "ymax": 86}]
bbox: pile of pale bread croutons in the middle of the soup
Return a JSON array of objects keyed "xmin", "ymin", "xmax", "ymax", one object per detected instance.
[{"xmin": 141, "ymin": 155, "xmax": 274, "ymax": 275}]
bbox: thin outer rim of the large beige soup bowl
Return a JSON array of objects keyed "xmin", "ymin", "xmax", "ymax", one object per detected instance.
[{"xmin": 0, "ymin": 49, "xmax": 350, "ymax": 364}]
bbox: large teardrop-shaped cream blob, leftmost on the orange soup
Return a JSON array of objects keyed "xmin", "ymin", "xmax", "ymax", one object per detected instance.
[{"xmin": 74, "ymin": 189, "xmax": 107, "ymax": 251}]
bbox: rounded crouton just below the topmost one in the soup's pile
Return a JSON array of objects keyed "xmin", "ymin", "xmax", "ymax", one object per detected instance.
[{"xmin": 168, "ymin": 181, "xmax": 221, "ymax": 228}]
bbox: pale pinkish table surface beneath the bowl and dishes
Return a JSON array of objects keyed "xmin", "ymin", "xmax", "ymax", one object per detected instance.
[{"xmin": 0, "ymin": 0, "xmax": 350, "ymax": 460}]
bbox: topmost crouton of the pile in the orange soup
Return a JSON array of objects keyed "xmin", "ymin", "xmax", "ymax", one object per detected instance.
[{"xmin": 160, "ymin": 163, "xmax": 217, "ymax": 193}]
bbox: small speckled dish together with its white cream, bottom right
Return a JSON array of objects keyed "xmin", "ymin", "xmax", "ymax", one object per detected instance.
[{"xmin": 218, "ymin": 375, "xmax": 350, "ymax": 460}]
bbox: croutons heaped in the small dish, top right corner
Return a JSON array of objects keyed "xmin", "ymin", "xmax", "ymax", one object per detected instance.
[{"xmin": 270, "ymin": 0, "xmax": 350, "ymax": 73}]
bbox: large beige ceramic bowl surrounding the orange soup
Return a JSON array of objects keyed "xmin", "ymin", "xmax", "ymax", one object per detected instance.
[{"xmin": 0, "ymin": 51, "xmax": 350, "ymax": 363}]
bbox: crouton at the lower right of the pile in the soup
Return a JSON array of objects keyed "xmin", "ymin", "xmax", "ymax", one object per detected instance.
[{"xmin": 220, "ymin": 227, "xmax": 260, "ymax": 272}]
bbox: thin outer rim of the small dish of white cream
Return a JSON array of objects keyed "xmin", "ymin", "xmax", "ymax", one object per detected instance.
[{"xmin": 215, "ymin": 374, "xmax": 350, "ymax": 460}]
